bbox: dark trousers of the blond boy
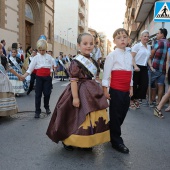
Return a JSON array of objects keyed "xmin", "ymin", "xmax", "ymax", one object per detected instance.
[{"xmin": 35, "ymin": 76, "xmax": 52, "ymax": 114}]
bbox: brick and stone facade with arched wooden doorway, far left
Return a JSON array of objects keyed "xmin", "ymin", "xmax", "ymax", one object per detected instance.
[{"xmin": 0, "ymin": 0, "xmax": 54, "ymax": 51}]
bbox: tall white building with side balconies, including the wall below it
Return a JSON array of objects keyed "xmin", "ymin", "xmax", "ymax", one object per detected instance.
[{"xmin": 54, "ymin": 0, "xmax": 89, "ymax": 55}]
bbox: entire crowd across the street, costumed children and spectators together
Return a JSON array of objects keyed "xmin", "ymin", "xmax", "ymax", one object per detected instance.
[{"xmin": 0, "ymin": 28, "xmax": 170, "ymax": 153}]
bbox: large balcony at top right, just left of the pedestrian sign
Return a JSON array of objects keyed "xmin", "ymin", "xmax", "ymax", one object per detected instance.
[{"xmin": 134, "ymin": 0, "xmax": 156, "ymax": 22}]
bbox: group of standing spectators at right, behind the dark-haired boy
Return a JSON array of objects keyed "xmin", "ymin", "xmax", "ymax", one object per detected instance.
[{"xmin": 130, "ymin": 28, "xmax": 170, "ymax": 118}]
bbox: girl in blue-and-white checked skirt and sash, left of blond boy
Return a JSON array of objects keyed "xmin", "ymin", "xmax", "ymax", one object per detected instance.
[{"xmin": 8, "ymin": 49, "xmax": 28, "ymax": 96}]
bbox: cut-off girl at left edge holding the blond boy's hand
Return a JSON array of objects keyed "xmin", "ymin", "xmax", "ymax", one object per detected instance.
[{"xmin": 0, "ymin": 43, "xmax": 22, "ymax": 116}]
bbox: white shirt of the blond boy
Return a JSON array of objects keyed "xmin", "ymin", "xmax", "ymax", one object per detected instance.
[{"xmin": 26, "ymin": 53, "xmax": 53, "ymax": 74}]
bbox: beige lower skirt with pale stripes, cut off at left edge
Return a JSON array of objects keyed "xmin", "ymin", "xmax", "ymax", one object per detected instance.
[{"xmin": 0, "ymin": 92, "xmax": 18, "ymax": 116}]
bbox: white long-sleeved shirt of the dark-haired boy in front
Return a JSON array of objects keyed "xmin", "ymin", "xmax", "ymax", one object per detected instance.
[{"xmin": 102, "ymin": 48, "xmax": 133, "ymax": 87}]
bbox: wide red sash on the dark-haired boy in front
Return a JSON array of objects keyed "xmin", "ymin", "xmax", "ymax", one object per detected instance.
[{"xmin": 110, "ymin": 70, "xmax": 132, "ymax": 92}]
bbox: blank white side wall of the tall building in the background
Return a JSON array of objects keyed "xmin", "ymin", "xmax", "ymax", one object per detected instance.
[{"xmin": 54, "ymin": 0, "xmax": 79, "ymax": 44}]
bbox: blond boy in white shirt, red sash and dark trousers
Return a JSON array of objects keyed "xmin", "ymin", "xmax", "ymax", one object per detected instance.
[{"xmin": 23, "ymin": 35, "xmax": 53, "ymax": 118}]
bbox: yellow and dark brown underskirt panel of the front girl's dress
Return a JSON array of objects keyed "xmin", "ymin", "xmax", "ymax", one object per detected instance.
[{"xmin": 63, "ymin": 109, "xmax": 110, "ymax": 148}]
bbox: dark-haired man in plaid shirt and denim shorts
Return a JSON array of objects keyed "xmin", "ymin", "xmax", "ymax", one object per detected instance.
[{"xmin": 148, "ymin": 28, "xmax": 170, "ymax": 107}]
